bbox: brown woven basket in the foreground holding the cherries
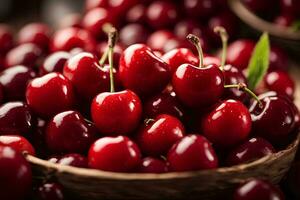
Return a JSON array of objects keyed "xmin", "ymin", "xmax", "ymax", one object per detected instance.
[{"xmin": 27, "ymin": 133, "xmax": 299, "ymax": 200}]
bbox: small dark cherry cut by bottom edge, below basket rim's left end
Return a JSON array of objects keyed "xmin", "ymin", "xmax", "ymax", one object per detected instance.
[{"xmin": 38, "ymin": 183, "xmax": 65, "ymax": 200}]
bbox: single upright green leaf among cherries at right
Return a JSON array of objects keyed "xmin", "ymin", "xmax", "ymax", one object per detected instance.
[{"xmin": 247, "ymin": 33, "xmax": 270, "ymax": 90}]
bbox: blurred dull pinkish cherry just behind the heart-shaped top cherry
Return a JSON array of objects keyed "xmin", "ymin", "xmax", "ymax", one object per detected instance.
[{"xmin": 119, "ymin": 24, "xmax": 149, "ymax": 46}]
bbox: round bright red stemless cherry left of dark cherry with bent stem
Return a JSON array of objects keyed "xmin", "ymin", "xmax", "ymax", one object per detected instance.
[{"xmin": 202, "ymin": 100, "xmax": 251, "ymax": 148}]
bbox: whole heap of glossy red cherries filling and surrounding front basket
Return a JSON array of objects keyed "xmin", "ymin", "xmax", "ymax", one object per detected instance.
[{"xmin": 0, "ymin": 0, "xmax": 300, "ymax": 200}]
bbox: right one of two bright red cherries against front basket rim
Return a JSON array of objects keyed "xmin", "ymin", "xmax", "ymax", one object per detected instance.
[{"xmin": 167, "ymin": 134, "xmax": 218, "ymax": 171}]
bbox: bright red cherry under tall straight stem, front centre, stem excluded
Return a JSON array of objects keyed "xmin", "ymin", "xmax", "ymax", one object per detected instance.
[{"xmin": 91, "ymin": 90, "xmax": 142, "ymax": 135}]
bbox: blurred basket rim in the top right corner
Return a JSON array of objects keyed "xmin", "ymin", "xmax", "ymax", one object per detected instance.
[{"xmin": 228, "ymin": 0, "xmax": 300, "ymax": 41}]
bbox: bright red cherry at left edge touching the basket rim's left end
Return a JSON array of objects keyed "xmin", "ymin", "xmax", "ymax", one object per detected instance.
[{"xmin": 0, "ymin": 135, "xmax": 35, "ymax": 156}]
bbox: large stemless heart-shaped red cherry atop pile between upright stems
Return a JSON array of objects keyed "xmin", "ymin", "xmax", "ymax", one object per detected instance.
[{"xmin": 119, "ymin": 44, "xmax": 170, "ymax": 97}]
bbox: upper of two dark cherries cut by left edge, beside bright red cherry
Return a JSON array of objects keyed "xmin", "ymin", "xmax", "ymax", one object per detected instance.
[{"xmin": 0, "ymin": 65, "xmax": 36, "ymax": 101}]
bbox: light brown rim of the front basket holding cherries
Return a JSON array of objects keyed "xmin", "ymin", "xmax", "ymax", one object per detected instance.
[{"xmin": 25, "ymin": 131, "xmax": 300, "ymax": 181}]
